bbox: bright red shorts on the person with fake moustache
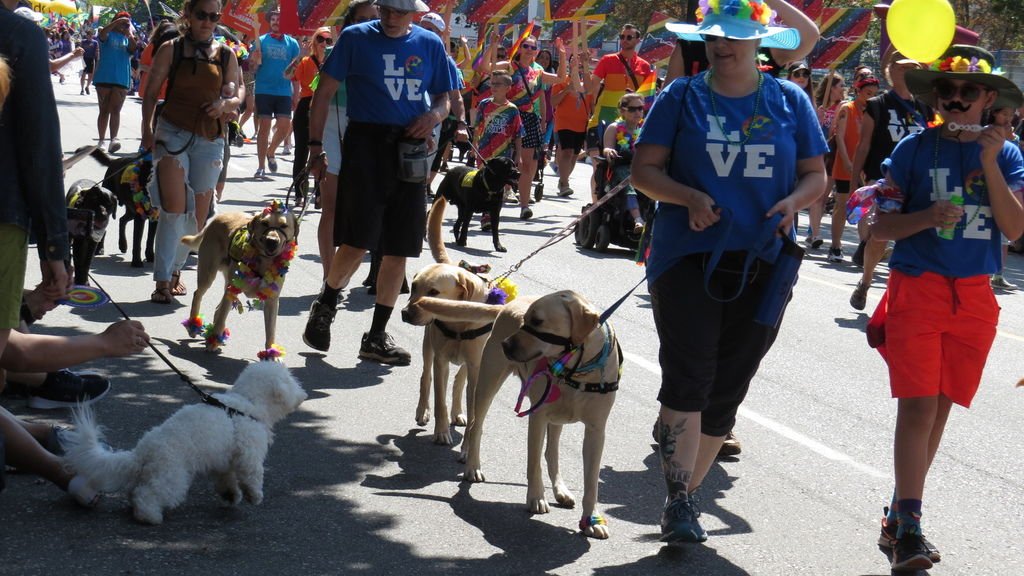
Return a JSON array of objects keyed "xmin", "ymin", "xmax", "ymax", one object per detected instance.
[{"xmin": 885, "ymin": 271, "xmax": 999, "ymax": 408}]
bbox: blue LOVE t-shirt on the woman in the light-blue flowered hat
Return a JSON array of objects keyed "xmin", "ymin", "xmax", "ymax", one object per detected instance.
[{"xmin": 637, "ymin": 73, "xmax": 828, "ymax": 282}]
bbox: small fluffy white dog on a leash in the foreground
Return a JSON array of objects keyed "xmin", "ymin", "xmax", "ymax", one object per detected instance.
[{"xmin": 66, "ymin": 362, "xmax": 306, "ymax": 524}]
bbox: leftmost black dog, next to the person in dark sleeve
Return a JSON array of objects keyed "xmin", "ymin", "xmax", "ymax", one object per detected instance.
[{"xmin": 65, "ymin": 180, "xmax": 118, "ymax": 285}]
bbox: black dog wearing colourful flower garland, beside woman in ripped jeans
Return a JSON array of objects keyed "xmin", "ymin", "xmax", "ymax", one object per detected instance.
[{"xmin": 80, "ymin": 148, "xmax": 157, "ymax": 268}]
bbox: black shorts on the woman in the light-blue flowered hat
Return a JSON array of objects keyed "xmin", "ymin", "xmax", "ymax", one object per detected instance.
[{"xmin": 649, "ymin": 252, "xmax": 784, "ymax": 437}]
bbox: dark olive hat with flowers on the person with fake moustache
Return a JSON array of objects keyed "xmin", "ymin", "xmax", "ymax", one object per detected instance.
[{"xmin": 906, "ymin": 44, "xmax": 1024, "ymax": 109}]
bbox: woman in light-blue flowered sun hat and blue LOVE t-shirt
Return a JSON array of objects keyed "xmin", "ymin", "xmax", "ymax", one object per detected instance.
[{"xmin": 632, "ymin": 0, "xmax": 827, "ymax": 542}]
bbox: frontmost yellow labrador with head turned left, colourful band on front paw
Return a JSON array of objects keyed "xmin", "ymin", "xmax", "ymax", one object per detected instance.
[{"xmin": 411, "ymin": 291, "xmax": 622, "ymax": 538}]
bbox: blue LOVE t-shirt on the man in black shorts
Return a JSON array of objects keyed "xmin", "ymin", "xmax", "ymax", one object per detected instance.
[{"xmin": 321, "ymin": 20, "xmax": 459, "ymax": 126}]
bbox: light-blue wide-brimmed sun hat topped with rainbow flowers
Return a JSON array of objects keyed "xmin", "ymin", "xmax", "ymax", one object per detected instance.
[{"xmin": 666, "ymin": 0, "xmax": 800, "ymax": 50}]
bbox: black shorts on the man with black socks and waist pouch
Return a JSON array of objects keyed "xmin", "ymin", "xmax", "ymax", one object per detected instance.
[{"xmin": 334, "ymin": 122, "xmax": 427, "ymax": 258}]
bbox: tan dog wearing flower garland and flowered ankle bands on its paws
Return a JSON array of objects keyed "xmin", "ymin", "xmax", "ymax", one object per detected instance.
[{"xmin": 181, "ymin": 202, "xmax": 299, "ymax": 358}]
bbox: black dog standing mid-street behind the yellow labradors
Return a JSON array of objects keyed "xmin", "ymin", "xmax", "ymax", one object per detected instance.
[{"xmin": 431, "ymin": 158, "xmax": 519, "ymax": 252}]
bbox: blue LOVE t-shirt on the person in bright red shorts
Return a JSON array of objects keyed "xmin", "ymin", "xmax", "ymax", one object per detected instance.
[{"xmin": 886, "ymin": 129, "xmax": 1024, "ymax": 278}]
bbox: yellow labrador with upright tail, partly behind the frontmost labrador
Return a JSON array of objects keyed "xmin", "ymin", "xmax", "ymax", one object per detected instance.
[{"xmin": 401, "ymin": 196, "xmax": 500, "ymax": 446}]
